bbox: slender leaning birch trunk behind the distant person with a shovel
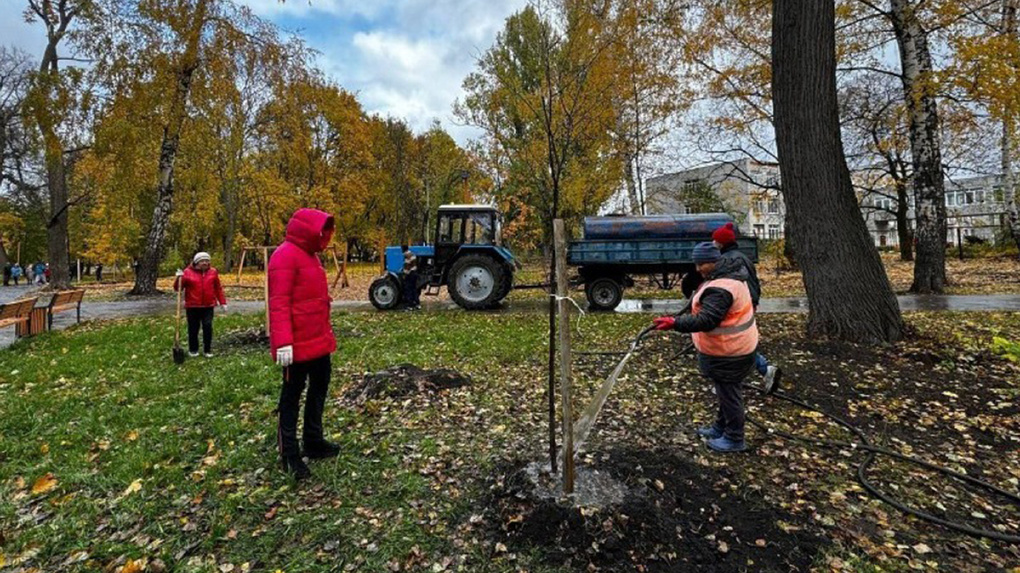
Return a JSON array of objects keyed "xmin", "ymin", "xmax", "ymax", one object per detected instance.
[{"xmin": 131, "ymin": 0, "xmax": 208, "ymax": 295}]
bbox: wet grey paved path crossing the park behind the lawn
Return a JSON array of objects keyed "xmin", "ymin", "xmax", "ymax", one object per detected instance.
[{"xmin": 0, "ymin": 287, "xmax": 1020, "ymax": 348}]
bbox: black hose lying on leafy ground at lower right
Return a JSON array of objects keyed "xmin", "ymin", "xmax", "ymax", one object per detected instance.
[{"xmin": 748, "ymin": 385, "xmax": 1020, "ymax": 544}]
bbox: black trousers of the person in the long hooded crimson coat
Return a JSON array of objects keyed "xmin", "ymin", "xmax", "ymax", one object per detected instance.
[{"xmin": 276, "ymin": 355, "xmax": 333, "ymax": 457}]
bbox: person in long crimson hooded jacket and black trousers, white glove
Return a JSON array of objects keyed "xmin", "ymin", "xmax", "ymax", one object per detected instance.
[{"xmin": 267, "ymin": 209, "xmax": 340, "ymax": 479}]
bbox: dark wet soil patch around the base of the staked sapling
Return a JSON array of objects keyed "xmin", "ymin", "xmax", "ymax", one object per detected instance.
[{"xmin": 490, "ymin": 450, "xmax": 820, "ymax": 571}]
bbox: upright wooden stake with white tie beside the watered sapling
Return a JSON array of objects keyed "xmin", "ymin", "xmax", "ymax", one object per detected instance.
[{"xmin": 553, "ymin": 219, "xmax": 574, "ymax": 494}]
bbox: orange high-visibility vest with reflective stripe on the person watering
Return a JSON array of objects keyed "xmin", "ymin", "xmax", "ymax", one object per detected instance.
[{"xmin": 691, "ymin": 278, "xmax": 758, "ymax": 356}]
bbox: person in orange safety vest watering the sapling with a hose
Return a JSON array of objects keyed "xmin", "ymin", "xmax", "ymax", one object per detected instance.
[{"xmin": 653, "ymin": 243, "xmax": 758, "ymax": 453}]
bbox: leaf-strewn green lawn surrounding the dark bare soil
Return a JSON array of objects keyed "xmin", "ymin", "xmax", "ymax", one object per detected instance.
[{"xmin": 0, "ymin": 312, "xmax": 1020, "ymax": 573}]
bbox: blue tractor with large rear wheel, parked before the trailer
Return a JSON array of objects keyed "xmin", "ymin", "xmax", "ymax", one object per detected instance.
[{"xmin": 368, "ymin": 205, "xmax": 517, "ymax": 310}]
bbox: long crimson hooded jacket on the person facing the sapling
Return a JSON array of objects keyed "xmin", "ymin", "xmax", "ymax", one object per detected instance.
[{"xmin": 268, "ymin": 209, "xmax": 337, "ymax": 362}]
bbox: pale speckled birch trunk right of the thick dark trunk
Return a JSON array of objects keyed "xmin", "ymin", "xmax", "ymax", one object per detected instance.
[{"xmin": 889, "ymin": 0, "xmax": 946, "ymax": 293}]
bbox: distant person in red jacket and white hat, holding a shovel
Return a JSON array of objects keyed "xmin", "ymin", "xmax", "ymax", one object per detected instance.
[{"xmin": 173, "ymin": 253, "xmax": 226, "ymax": 358}]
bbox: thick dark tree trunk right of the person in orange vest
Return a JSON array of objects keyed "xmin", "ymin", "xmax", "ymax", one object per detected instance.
[{"xmin": 772, "ymin": 0, "xmax": 903, "ymax": 343}]
